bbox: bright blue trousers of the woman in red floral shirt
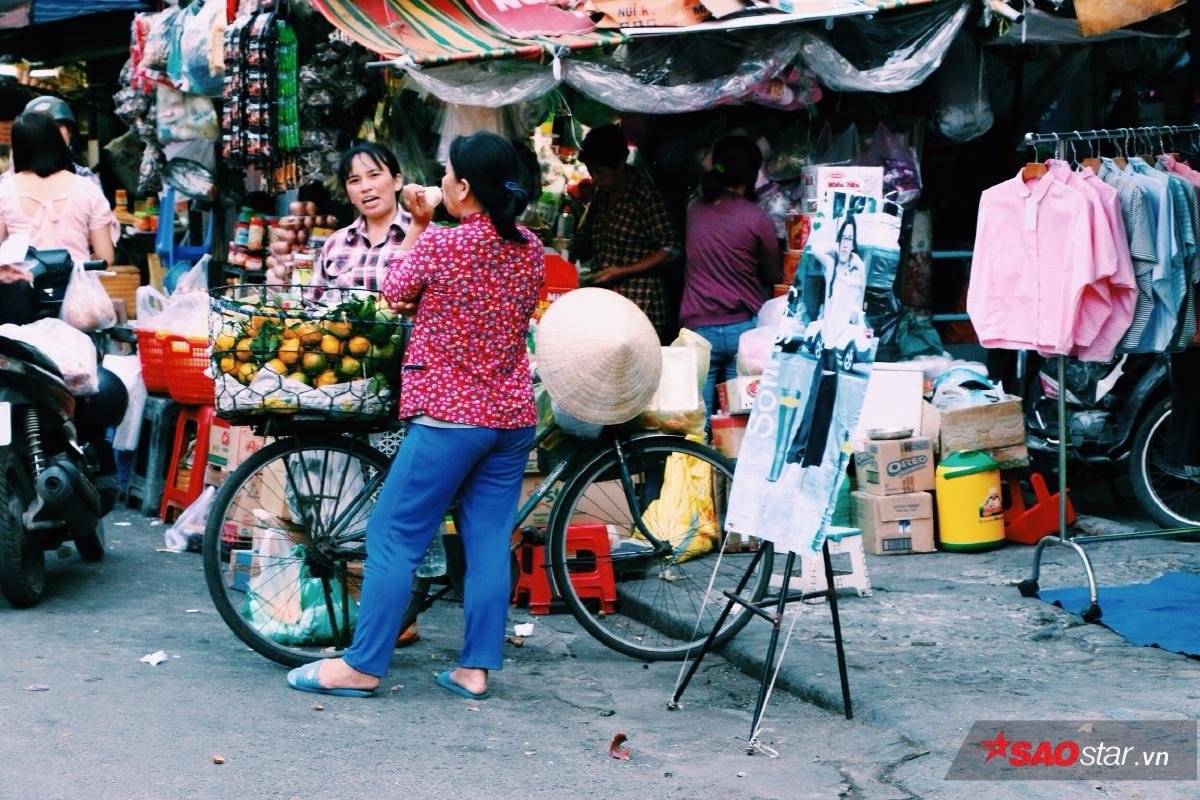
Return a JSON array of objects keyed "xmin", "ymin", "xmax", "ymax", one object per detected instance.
[{"xmin": 343, "ymin": 425, "xmax": 534, "ymax": 678}]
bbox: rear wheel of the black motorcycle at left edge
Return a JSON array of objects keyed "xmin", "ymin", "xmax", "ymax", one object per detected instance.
[{"xmin": 0, "ymin": 447, "xmax": 46, "ymax": 608}]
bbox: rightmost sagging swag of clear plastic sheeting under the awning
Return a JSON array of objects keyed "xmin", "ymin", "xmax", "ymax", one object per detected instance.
[{"xmin": 799, "ymin": 1, "xmax": 970, "ymax": 94}]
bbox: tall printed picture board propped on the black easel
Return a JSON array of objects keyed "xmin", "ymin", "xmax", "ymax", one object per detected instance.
[{"xmin": 726, "ymin": 191, "xmax": 901, "ymax": 557}]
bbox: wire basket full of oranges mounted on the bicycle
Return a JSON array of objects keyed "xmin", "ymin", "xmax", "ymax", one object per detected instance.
[{"xmin": 210, "ymin": 284, "xmax": 410, "ymax": 420}]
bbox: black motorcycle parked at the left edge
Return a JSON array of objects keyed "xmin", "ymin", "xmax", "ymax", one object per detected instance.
[{"xmin": 0, "ymin": 248, "xmax": 116, "ymax": 608}]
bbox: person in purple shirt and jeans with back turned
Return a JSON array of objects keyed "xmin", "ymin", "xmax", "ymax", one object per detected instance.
[{"xmin": 679, "ymin": 136, "xmax": 782, "ymax": 415}]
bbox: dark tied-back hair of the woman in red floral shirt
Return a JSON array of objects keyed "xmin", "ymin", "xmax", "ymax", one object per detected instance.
[{"xmin": 450, "ymin": 131, "xmax": 529, "ymax": 242}]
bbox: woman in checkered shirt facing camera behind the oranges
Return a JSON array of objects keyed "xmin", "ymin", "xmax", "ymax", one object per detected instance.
[{"xmin": 308, "ymin": 142, "xmax": 413, "ymax": 289}]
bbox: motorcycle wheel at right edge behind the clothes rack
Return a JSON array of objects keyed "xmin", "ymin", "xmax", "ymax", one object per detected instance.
[{"xmin": 1129, "ymin": 398, "xmax": 1200, "ymax": 529}]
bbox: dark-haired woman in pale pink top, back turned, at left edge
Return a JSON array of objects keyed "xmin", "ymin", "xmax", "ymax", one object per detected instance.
[{"xmin": 0, "ymin": 112, "xmax": 119, "ymax": 264}]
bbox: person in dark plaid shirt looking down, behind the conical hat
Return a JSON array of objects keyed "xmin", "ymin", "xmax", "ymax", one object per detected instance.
[{"xmin": 575, "ymin": 125, "xmax": 679, "ymax": 344}]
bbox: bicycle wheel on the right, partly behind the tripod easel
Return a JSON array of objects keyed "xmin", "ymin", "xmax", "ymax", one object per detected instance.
[{"xmin": 547, "ymin": 435, "xmax": 773, "ymax": 661}]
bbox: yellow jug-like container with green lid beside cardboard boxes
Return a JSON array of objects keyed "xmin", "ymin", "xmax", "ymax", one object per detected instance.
[{"xmin": 936, "ymin": 451, "xmax": 1004, "ymax": 553}]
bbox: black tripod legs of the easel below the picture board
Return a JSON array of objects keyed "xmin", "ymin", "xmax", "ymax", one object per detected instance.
[{"xmin": 667, "ymin": 541, "xmax": 854, "ymax": 753}]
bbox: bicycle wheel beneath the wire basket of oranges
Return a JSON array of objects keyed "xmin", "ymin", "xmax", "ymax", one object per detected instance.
[{"xmin": 203, "ymin": 434, "xmax": 389, "ymax": 667}]
